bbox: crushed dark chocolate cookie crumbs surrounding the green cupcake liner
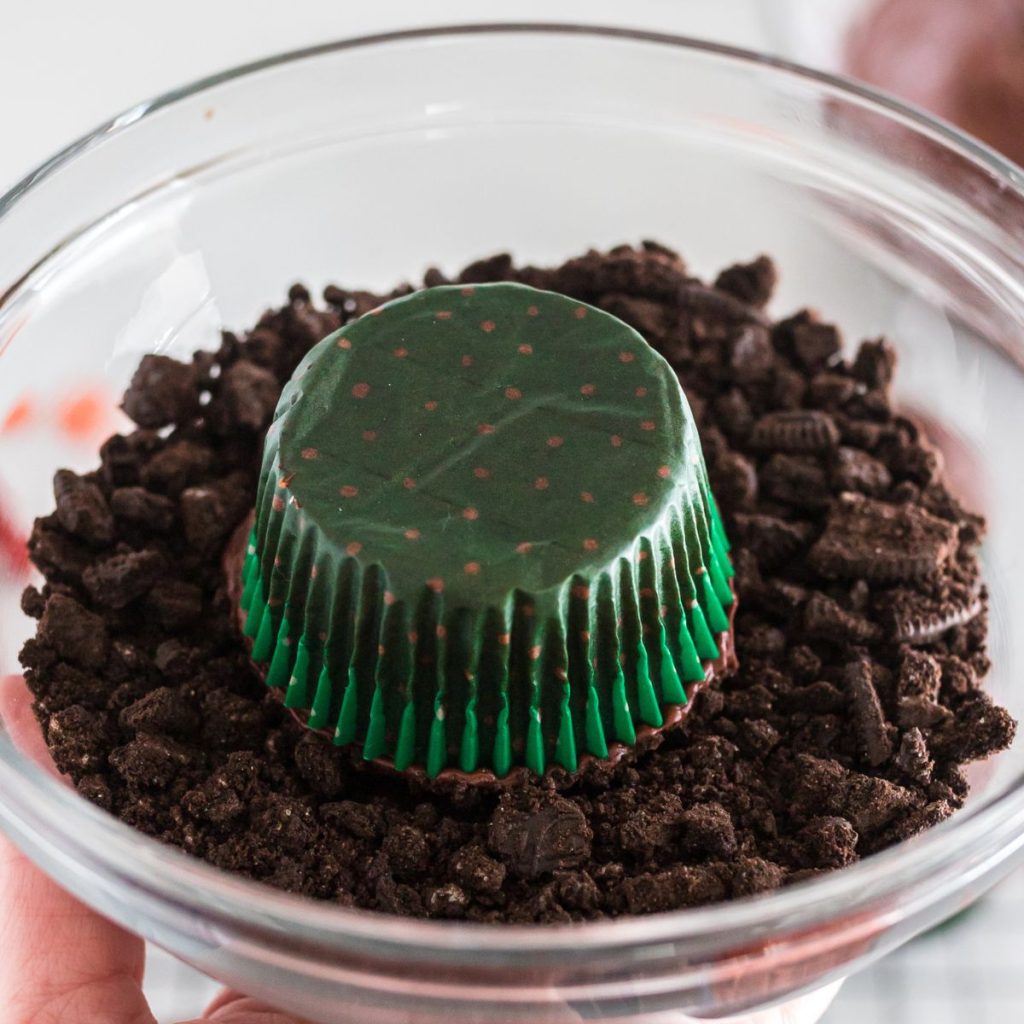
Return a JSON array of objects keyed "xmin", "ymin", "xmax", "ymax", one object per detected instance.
[{"xmin": 22, "ymin": 242, "xmax": 1015, "ymax": 922}]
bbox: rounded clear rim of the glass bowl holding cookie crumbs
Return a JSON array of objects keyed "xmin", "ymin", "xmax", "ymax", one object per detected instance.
[{"xmin": 0, "ymin": 22, "xmax": 1024, "ymax": 963}]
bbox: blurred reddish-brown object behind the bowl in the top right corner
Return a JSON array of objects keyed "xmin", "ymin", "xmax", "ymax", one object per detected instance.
[{"xmin": 845, "ymin": 0, "xmax": 1024, "ymax": 164}]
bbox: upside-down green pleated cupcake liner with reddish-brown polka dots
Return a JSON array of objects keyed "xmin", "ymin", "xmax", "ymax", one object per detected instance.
[{"xmin": 241, "ymin": 284, "xmax": 733, "ymax": 777}]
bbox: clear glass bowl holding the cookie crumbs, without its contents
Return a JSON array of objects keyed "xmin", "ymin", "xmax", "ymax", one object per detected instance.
[{"xmin": 0, "ymin": 26, "xmax": 1024, "ymax": 1024}]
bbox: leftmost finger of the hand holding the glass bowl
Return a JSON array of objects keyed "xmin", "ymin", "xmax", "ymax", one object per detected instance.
[{"xmin": 0, "ymin": 679, "xmax": 154, "ymax": 1024}]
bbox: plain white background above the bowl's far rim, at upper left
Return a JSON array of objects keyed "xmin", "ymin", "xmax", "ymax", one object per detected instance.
[{"xmin": 0, "ymin": 0, "xmax": 770, "ymax": 191}]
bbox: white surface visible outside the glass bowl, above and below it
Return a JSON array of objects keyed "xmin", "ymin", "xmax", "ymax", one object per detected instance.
[{"xmin": 0, "ymin": 0, "xmax": 1024, "ymax": 1024}]
